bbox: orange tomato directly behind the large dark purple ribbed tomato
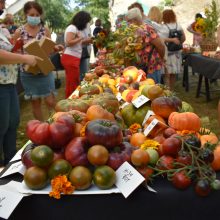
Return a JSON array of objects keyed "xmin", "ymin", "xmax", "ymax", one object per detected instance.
[{"xmin": 86, "ymin": 105, "xmax": 115, "ymax": 121}]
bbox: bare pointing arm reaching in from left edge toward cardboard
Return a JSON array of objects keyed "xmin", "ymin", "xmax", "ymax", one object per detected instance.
[{"xmin": 0, "ymin": 50, "xmax": 41, "ymax": 66}]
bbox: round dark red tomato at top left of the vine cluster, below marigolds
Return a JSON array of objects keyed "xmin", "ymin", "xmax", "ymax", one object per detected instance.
[{"xmin": 163, "ymin": 137, "xmax": 182, "ymax": 156}]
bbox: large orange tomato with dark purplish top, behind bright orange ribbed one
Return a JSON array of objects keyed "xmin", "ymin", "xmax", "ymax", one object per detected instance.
[{"xmin": 151, "ymin": 97, "xmax": 178, "ymax": 118}]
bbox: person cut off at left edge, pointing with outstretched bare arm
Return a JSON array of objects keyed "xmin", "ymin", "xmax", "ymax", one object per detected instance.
[{"xmin": 0, "ymin": 0, "xmax": 39, "ymax": 167}]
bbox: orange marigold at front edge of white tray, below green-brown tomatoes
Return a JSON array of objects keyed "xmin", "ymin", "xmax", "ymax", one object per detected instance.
[{"xmin": 49, "ymin": 175, "xmax": 75, "ymax": 199}]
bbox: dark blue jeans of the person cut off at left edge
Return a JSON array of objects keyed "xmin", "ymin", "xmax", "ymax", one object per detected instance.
[{"xmin": 0, "ymin": 84, "xmax": 20, "ymax": 165}]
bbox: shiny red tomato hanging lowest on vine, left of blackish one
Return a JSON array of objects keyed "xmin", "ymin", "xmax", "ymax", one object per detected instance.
[{"xmin": 172, "ymin": 171, "xmax": 191, "ymax": 189}]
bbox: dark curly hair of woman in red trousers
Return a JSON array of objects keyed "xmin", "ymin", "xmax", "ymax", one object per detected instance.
[{"xmin": 71, "ymin": 11, "xmax": 91, "ymax": 31}]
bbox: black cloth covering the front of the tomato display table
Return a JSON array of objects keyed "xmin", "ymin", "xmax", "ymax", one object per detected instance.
[{"xmin": 0, "ymin": 165, "xmax": 220, "ymax": 220}]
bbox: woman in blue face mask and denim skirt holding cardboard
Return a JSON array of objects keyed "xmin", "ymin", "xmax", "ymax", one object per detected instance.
[{"xmin": 14, "ymin": 1, "xmax": 63, "ymax": 121}]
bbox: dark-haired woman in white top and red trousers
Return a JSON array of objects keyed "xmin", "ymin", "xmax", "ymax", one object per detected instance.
[{"xmin": 61, "ymin": 11, "xmax": 91, "ymax": 98}]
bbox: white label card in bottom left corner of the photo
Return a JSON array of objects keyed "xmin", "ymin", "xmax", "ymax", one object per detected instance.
[{"xmin": 0, "ymin": 187, "xmax": 23, "ymax": 219}]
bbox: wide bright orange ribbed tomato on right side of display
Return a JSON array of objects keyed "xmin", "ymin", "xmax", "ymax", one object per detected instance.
[{"xmin": 168, "ymin": 112, "xmax": 201, "ymax": 131}]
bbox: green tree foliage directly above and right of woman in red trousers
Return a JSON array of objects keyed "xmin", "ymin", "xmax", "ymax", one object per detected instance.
[{"xmin": 75, "ymin": 0, "xmax": 109, "ymax": 26}]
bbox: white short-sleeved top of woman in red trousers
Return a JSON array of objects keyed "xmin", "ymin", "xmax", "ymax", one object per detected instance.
[{"xmin": 64, "ymin": 24, "xmax": 82, "ymax": 58}]
